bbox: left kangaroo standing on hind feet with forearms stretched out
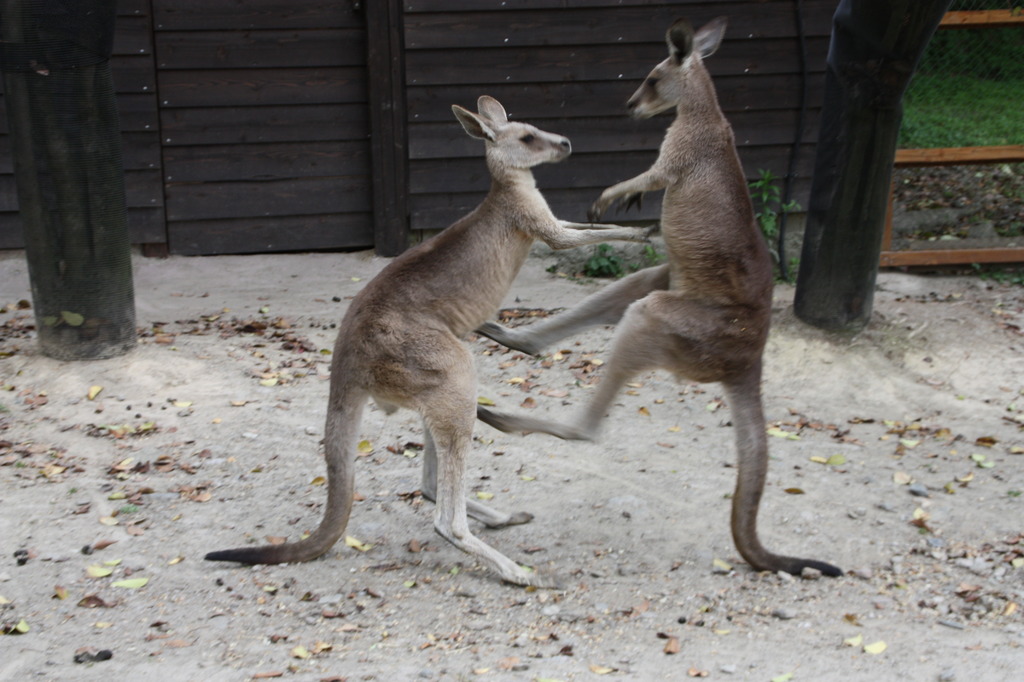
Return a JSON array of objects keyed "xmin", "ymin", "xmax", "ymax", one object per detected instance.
[{"xmin": 206, "ymin": 95, "xmax": 648, "ymax": 586}]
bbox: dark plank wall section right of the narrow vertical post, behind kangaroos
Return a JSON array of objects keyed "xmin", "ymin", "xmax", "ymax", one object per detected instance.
[{"xmin": 403, "ymin": 0, "xmax": 837, "ymax": 229}]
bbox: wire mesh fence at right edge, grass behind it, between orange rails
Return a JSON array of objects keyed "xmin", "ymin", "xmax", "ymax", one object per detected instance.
[{"xmin": 892, "ymin": 0, "xmax": 1024, "ymax": 262}]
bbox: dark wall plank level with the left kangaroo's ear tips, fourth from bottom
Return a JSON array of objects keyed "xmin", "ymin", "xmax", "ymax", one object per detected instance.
[{"xmin": 407, "ymin": 73, "xmax": 824, "ymax": 123}]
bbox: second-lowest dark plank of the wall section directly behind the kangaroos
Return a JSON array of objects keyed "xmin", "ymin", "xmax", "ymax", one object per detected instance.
[{"xmin": 410, "ymin": 145, "xmax": 814, "ymax": 195}]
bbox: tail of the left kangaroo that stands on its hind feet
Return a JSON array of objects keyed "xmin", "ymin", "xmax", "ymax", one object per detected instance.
[{"xmin": 204, "ymin": 377, "xmax": 367, "ymax": 563}]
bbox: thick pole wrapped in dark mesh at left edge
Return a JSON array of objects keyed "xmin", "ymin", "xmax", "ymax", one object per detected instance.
[{"xmin": 0, "ymin": 0, "xmax": 136, "ymax": 359}]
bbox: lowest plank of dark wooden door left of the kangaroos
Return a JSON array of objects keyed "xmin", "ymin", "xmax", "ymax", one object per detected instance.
[{"xmin": 170, "ymin": 213, "xmax": 374, "ymax": 256}]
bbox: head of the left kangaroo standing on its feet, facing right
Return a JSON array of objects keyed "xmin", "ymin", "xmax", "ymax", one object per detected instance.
[{"xmin": 452, "ymin": 95, "xmax": 572, "ymax": 173}]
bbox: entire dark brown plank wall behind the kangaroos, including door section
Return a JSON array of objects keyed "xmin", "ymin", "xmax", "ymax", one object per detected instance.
[{"xmin": 0, "ymin": 0, "xmax": 836, "ymax": 254}]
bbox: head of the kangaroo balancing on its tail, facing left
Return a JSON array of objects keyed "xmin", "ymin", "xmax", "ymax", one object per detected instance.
[{"xmin": 626, "ymin": 16, "xmax": 726, "ymax": 119}]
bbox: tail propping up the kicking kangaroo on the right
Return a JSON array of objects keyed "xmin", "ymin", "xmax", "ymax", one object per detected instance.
[{"xmin": 724, "ymin": 359, "xmax": 843, "ymax": 577}]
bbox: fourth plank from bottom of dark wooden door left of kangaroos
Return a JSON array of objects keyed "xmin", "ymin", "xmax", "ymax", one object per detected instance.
[{"xmin": 161, "ymin": 103, "xmax": 370, "ymax": 146}]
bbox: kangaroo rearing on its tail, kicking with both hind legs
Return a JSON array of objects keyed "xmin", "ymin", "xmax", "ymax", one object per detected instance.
[{"xmin": 477, "ymin": 17, "xmax": 842, "ymax": 576}]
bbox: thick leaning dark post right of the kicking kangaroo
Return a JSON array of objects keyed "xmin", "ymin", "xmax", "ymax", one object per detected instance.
[{"xmin": 794, "ymin": 0, "xmax": 949, "ymax": 332}]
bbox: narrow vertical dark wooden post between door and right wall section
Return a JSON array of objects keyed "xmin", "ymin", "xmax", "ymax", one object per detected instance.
[{"xmin": 365, "ymin": 0, "xmax": 409, "ymax": 256}]
